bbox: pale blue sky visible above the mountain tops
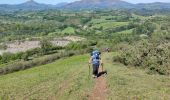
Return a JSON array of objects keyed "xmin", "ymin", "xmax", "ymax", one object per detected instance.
[{"xmin": 0, "ymin": 0, "xmax": 170, "ymax": 4}]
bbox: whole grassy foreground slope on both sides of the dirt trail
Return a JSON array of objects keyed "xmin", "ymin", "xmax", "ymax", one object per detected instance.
[{"xmin": 0, "ymin": 53, "xmax": 170, "ymax": 100}]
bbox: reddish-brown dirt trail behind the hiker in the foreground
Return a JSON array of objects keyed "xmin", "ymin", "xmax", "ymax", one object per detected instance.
[{"xmin": 89, "ymin": 69, "xmax": 107, "ymax": 100}]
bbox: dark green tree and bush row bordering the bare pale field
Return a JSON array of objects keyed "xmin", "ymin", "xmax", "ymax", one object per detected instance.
[{"xmin": 0, "ymin": 41, "xmax": 63, "ymax": 64}]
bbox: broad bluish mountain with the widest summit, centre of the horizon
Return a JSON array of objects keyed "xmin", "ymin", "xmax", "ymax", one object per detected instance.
[{"xmin": 64, "ymin": 0, "xmax": 134, "ymax": 9}]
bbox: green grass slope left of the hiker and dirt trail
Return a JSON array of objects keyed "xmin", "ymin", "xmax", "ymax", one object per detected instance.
[{"xmin": 0, "ymin": 55, "xmax": 93, "ymax": 100}]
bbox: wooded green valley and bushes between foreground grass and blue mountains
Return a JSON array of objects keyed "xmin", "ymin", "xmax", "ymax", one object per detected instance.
[{"xmin": 0, "ymin": 10, "xmax": 170, "ymax": 74}]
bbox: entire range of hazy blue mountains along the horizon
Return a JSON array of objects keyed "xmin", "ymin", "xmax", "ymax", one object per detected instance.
[{"xmin": 0, "ymin": 0, "xmax": 170, "ymax": 11}]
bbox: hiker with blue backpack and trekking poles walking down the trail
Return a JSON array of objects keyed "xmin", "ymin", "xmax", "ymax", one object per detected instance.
[{"xmin": 89, "ymin": 50, "xmax": 103, "ymax": 78}]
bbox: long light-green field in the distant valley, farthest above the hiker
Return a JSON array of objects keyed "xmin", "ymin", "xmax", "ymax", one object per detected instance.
[{"xmin": 92, "ymin": 22, "xmax": 128, "ymax": 29}]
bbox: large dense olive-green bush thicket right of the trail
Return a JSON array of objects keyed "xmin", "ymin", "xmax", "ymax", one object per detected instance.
[{"xmin": 114, "ymin": 41, "xmax": 170, "ymax": 75}]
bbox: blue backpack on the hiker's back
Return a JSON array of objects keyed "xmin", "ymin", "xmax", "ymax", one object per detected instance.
[{"xmin": 91, "ymin": 50, "xmax": 101, "ymax": 64}]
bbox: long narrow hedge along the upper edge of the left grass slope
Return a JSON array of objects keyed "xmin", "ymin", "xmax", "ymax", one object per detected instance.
[{"xmin": 0, "ymin": 51, "xmax": 84, "ymax": 74}]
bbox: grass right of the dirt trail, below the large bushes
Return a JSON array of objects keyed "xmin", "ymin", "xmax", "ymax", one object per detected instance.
[{"xmin": 105, "ymin": 54, "xmax": 170, "ymax": 100}]
